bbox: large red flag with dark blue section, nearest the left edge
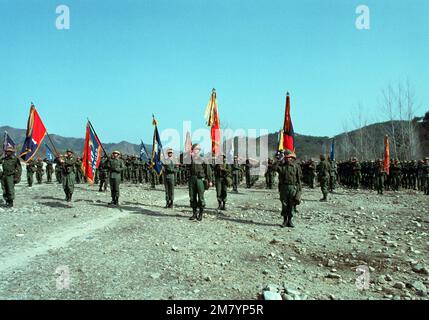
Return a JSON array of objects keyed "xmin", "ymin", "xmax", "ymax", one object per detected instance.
[{"xmin": 20, "ymin": 104, "xmax": 47, "ymax": 162}]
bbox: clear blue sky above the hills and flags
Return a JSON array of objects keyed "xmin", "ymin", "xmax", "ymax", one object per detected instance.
[{"xmin": 0, "ymin": 0, "xmax": 429, "ymax": 143}]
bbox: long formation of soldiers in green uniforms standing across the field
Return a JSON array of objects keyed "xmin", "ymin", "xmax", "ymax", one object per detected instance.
[{"xmin": 0, "ymin": 144, "xmax": 429, "ymax": 228}]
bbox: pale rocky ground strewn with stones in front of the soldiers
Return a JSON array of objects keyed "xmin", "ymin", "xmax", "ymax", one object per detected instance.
[{"xmin": 0, "ymin": 175, "xmax": 429, "ymax": 300}]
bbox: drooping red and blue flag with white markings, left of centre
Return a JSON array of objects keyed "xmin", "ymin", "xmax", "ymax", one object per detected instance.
[{"xmin": 82, "ymin": 121, "xmax": 101, "ymax": 184}]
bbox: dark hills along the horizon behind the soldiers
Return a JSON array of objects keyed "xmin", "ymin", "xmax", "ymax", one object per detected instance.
[{"xmin": 0, "ymin": 112, "xmax": 429, "ymax": 160}]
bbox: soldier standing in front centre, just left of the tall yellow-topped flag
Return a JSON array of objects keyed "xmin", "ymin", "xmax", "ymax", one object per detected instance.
[{"xmin": 185, "ymin": 144, "xmax": 211, "ymax": 221}]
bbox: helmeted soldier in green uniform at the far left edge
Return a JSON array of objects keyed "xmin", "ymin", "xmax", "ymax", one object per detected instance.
[{"xmin": 0, "ymin": 147, "xmax": 22, "ymax": 208}]
